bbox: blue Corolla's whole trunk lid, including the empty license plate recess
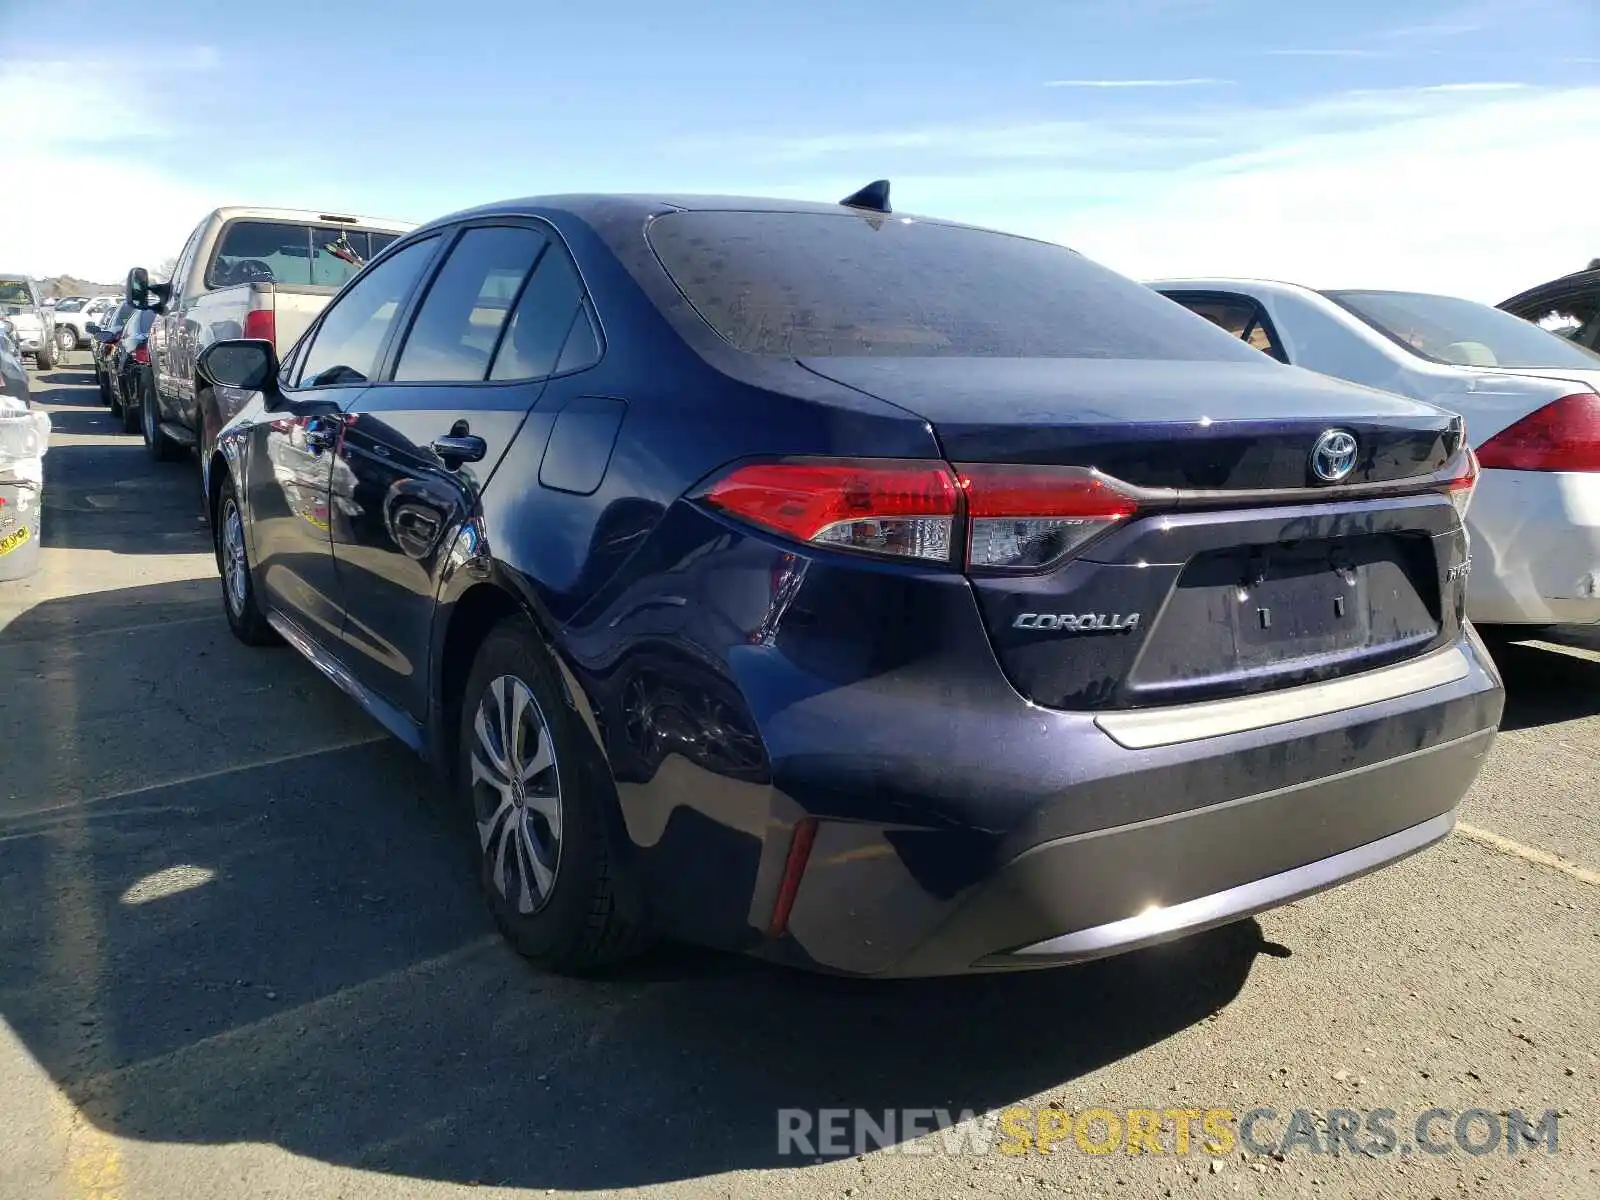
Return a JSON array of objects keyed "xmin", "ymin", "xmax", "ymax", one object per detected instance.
[{"xmin": 803, "ymin": 357, "xmax": 1469, "ymax": 710}]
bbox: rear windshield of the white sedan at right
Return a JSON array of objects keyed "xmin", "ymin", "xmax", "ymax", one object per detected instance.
[{"xmin": 1323, "ymin": 291, "xmax": 1600, "ymax": 371}]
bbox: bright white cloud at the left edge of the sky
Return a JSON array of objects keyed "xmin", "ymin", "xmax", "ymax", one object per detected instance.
[{"xmin": 0, "ymin": 46, "xmax": 219, "ymax": 283}]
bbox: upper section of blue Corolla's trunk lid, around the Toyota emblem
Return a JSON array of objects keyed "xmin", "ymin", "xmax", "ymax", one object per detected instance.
[{"xmin": 802, "ymin": 355, "xmax": 1454, "ymax": 490}]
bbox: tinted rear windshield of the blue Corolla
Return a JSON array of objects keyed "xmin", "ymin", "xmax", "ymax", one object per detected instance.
[{"xmin": 650, "ymin": 211, "xmax": 1261, "ymax": 363}]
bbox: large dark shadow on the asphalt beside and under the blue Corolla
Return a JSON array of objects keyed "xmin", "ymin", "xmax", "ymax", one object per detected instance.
[{"xmin": 0, "ymin": 582, "xmax": 1269, "ymax": 1189}]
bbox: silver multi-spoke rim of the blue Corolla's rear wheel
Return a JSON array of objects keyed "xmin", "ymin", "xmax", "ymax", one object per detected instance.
[{"xmin": 472, "ymin": 675, "xmax": 562, "ymax": 915}]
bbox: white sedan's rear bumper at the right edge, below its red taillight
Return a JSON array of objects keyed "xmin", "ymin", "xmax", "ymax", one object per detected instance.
[{"xmin": 1467, "ymin": 470, "xmax": 1600, "ymax": 626}]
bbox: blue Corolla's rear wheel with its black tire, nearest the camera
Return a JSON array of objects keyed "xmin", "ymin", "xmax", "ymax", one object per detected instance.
[{"xmin": 456, "ymin": 618, "xmax": 651, "ymax": 974}]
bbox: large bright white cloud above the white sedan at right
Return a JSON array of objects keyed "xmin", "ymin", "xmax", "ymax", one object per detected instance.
[{"xmin": 1026, "ymin": 86, "xmax": 1600, "ymax": 302}]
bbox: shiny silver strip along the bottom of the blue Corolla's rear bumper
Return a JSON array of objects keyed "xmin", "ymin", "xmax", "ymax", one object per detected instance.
[{"xmin": 979, "ymin": 810, "xmax": 1456, "ymax": 966}]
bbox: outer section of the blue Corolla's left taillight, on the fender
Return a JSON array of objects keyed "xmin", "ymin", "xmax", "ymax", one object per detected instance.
[{"xmin": 706, "ymin": 459, "xmax": 958, "ymax": 562}]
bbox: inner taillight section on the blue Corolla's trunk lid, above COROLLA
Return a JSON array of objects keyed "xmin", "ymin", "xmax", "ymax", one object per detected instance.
[{"xmin": 955, "ymin": 462, "xmax": 1139, "ymax": 571}]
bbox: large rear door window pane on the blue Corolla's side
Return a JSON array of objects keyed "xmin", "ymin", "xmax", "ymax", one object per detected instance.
[{"xmin": 394, "ymin": 226, "xmax": 549, "ymax": 382}]
